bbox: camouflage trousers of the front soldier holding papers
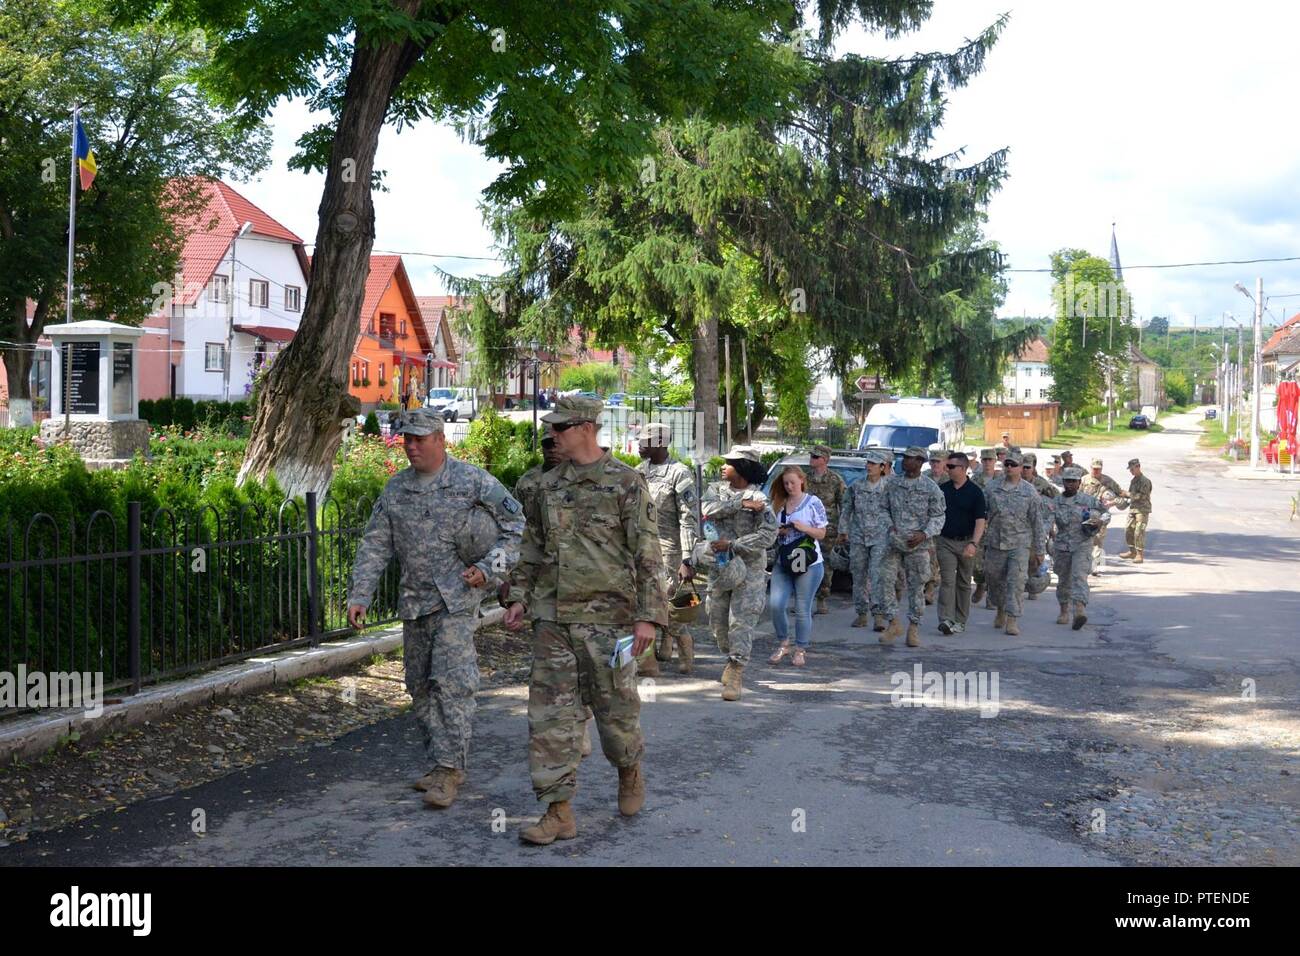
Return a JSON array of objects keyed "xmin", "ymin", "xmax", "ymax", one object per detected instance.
[{"xmin": 528, "ymin": 620, "xmax": 645, "ymax": 804}]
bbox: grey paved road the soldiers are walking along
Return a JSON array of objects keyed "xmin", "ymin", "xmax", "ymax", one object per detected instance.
[{"xmin": 0, "ymin": 416, "xmax": 1300, "ymax": 865}]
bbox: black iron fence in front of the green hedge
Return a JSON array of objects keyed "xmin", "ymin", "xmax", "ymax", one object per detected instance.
[{"xmin": 0, "ymin": 494, "xmax": 398, "ymax": 692}]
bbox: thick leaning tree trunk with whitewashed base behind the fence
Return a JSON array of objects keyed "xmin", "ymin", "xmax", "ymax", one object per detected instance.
[{"xmin": 239, "ymin": 0, "xmax": 421, "ymax": 496}]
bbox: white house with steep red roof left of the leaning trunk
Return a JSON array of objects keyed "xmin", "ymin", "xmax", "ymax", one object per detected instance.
[{"xmin": 140, "ymin": 178, "xmax": 309, "ymax": 401}]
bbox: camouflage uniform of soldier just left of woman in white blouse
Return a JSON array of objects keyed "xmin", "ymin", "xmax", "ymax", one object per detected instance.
[{"xmin": 703, "ymin": 480, "xmax": 777, "ymax": 667}]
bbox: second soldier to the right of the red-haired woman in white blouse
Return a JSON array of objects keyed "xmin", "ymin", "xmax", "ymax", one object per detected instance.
[{"xmin": 840, "ymin": 449, "xmax": 896, "ymax": 631}]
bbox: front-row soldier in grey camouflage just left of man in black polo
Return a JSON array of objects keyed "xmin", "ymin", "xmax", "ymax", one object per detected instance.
[{"xmin": 880, "ymin": 445, "xmax": 946, "ymax": 648}]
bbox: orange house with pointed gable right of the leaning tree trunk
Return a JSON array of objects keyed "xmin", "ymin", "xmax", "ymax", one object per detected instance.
[{"xmin": 348, "ymin": 255, "xmax": 433, "ymax": 411}]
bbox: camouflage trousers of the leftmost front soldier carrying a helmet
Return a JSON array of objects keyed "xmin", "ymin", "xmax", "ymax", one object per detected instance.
[{"xmin": 402, "ymin": 607, "xmax": 478, "ymax": 770}]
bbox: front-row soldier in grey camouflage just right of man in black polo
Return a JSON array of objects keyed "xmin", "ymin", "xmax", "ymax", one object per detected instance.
[{"xmin": 984, "ymin": 451, "xmax": 1048, "ymax": 635}]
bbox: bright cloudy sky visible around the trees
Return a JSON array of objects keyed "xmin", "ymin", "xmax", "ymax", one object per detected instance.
[{"xmin": 233, "ymin": 0, "xmax": 1300, "ymax": 328}]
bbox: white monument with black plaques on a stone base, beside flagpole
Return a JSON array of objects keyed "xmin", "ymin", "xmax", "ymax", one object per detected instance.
[{"xmin": 40, "ymin": 321, "xmax": 150, "ymax": 468}]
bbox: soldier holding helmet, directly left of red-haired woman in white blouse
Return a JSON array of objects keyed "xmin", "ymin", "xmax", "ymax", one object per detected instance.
[{"xmin": 697, "ymin": 445, "xmax": 777, "ymax": 700}]
